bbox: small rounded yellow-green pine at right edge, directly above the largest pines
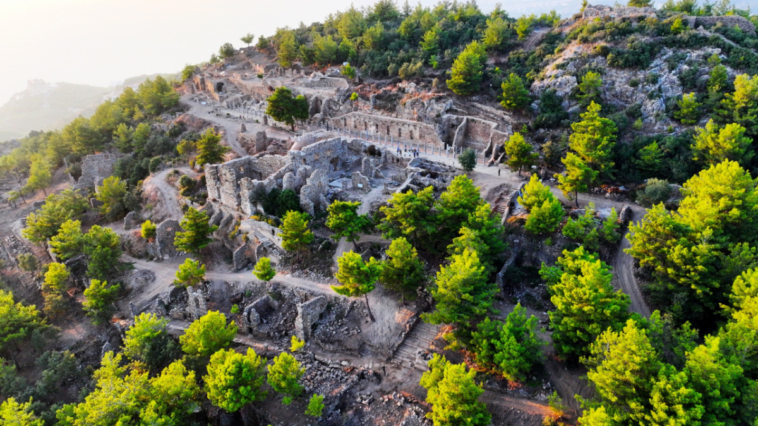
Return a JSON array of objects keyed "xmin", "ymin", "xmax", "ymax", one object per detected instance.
[{"xmin": 692, "ymin": 120, "xmax": 754, "ymax": 165}]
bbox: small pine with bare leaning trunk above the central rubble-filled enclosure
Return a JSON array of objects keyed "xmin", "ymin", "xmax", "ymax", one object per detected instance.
[{"xmin": 332, "ymin": 251, "xmax": 382, "ymax": 321}]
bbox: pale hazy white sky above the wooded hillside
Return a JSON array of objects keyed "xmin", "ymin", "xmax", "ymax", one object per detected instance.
[{"xmin": 0, "ymin": 0, "xmax": 755, "ymax": 104}]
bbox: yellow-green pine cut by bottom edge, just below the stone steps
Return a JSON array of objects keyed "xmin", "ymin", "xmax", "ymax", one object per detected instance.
[{"xmin": 421, "ymin": 354, "xmax": 491, "ymax": 426}]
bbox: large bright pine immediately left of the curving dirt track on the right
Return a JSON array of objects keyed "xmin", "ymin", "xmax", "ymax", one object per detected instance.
[{"xmin": 549, "ymin": 250, "xmax": 630, "ymax": 359}]
